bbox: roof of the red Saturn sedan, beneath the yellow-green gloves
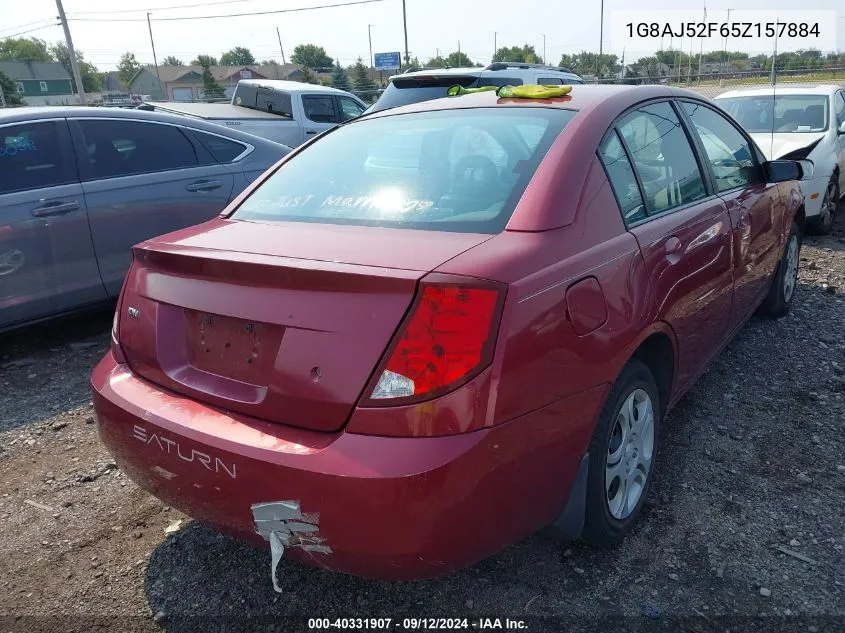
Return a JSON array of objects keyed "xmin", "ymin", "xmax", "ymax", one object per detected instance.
[{"xmin": 363, "ymin": 84, "xmax": 707, "ymax": 119}]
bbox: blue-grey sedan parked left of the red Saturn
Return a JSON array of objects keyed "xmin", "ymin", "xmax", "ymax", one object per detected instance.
[{"xmin": 0, "ymin": 107, "xmax": 290, "ymax": 330}]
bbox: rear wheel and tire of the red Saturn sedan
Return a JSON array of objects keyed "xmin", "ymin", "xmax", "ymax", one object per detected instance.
[{"xmin": 583, "ymin": 358, "xmax": 662, "ymax": 547}]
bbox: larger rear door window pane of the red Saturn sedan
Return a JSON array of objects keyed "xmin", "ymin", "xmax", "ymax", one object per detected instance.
[{"xmin": 619, "ymin": 102, "xmax": 707, "ymax": 215}]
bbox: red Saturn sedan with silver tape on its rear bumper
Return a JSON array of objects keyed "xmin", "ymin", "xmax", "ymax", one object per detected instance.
[{"xmin": 92, "ymin": 86, "xmax": 804, "ymax": 578}]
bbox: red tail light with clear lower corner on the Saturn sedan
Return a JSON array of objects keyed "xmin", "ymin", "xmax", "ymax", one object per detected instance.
[{"xmin": 369, "ymin": 275, "xmax": 505, "ymax": 406}]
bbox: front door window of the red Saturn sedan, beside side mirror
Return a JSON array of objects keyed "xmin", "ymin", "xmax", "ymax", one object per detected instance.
[{"xmin": 682, "ymin": 101, "xmax": 760, "ymax": 191}]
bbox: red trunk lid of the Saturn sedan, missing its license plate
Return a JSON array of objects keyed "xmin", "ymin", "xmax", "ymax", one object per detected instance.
[{"xmin": 119, "ymin": 219, "xmax": 491, "ymax": 431}]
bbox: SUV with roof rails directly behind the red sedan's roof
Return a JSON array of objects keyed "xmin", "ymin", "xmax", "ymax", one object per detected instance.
[{"xmin": 367, "ymin": 62, "xmax": 584, "ymax": 114}]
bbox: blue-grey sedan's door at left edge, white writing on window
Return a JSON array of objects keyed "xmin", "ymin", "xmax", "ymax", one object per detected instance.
[{"xmin": 0, "ymin": 119, "xmax": 106, "ymax": 329}]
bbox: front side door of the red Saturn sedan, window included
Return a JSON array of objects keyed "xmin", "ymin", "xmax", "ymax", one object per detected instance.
[{"xmin": 681, "ymin": 101, "xmax": 785, "ymax": 327}]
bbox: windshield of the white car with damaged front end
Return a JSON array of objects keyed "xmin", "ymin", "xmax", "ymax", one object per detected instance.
[{"xmin": 716, "ymin": 95, "xmax": 828, "ymax": 134}]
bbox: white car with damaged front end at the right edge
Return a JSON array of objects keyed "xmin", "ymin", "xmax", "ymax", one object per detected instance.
[{"xmin": 716, "ymin": 85, "xmax": 845, "ymax": 233}]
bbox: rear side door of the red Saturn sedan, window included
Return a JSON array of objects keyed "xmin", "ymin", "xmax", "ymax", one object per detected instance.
[{"xmin": 601, "ymin": 101, "xmax": 732, "ymax": 387}]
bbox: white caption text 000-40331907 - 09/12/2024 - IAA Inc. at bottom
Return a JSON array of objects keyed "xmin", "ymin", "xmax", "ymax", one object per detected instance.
[{"xmin": 308, "ymin": 618, "xmax": 528, "ymax": 631}]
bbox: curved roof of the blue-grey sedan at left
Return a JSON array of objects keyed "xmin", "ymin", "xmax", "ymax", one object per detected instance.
[{"xmin": 0, "ymin": 106, "xmax": 286, "ymax": 145}]
